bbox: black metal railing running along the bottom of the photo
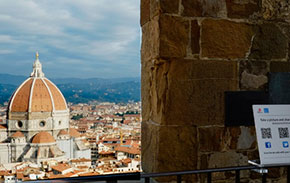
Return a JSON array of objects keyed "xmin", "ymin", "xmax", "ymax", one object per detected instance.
[{"xmin": 31, "ymin": 165, "xmax": 290, "ymax": 183}]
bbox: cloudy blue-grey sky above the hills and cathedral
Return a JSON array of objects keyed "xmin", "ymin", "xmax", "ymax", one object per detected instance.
[{"xmin": 0, "ymin": 0, "xmax": 140, "ymax": 78}]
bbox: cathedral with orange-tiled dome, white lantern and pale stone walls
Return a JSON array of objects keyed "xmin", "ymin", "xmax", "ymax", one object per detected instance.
[{"xmin": 0, "ymin": 53, "xmax": 91, "ymax": 163}]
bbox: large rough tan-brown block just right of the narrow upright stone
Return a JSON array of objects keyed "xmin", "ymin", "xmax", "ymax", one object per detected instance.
[{"xmin": 201, "ymin": 19, "xmax": 254, "ymax": 59}]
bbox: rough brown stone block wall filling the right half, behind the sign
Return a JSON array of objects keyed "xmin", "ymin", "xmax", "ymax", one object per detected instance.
[{"xmin": 140, "ymin": 0, "xmax": 290, "ymax": 182}]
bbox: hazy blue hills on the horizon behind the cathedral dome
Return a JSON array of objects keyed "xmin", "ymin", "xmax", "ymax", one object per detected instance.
[{"xmin": 0, "ymin": 74, "xmax": 141, "ymax": 104}]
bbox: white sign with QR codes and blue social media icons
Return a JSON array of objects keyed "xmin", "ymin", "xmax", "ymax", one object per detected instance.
[{"xmin": 253, "ymin": 105, "xmax": 290, "ymax": 165}]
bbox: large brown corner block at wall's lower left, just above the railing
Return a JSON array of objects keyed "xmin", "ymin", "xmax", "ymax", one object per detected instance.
[{"xmin": 142, "ymin": 121, "xmax": 198, "ymax": 182}]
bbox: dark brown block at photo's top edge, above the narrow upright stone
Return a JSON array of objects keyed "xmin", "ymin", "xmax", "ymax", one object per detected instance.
[{"xmin": 182, "ymin": 0, "xmax": 226, "ymax": 17}]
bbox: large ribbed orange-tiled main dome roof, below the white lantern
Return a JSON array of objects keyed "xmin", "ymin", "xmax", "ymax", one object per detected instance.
[{"xmin": 8, "ymin": 77, "xmax": 67, "ymax": 112}]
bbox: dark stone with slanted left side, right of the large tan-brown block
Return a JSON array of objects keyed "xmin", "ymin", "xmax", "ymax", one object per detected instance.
[{"xmin": 249, "ymin": 24, "xmax": 288, "ymax": 60}]
